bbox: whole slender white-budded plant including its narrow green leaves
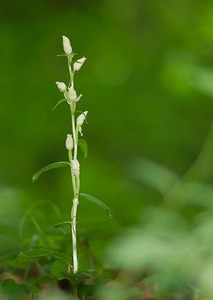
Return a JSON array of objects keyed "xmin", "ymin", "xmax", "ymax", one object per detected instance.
[{"xmin": 32, "ymin": 36, "xmax": 111, "ymax": 274}]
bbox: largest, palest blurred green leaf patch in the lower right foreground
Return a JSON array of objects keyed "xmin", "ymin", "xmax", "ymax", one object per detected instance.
[{"xmin": 108, "ymin": 208, "xmax": 188, "ymax": 271}]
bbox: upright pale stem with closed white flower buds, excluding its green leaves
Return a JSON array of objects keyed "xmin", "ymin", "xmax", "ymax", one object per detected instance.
[{"xmin": 56, "ymin": 36, "xmax": 87, "ymax": 274}]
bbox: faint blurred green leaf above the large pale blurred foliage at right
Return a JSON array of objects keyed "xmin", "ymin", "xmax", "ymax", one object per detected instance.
[{"xmin": 132, "ymin": 159, "xmax": 178, "ymax": 195}]
